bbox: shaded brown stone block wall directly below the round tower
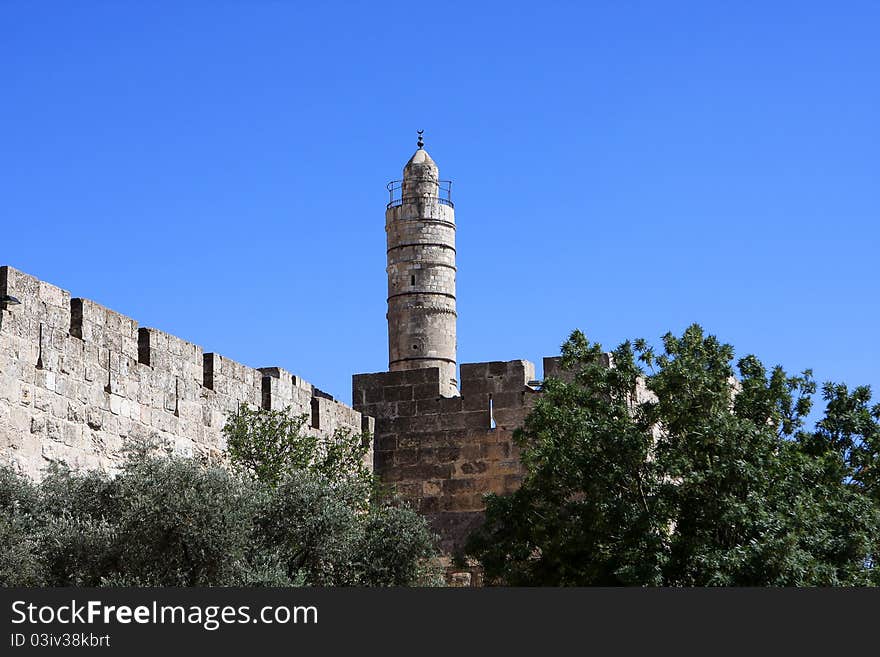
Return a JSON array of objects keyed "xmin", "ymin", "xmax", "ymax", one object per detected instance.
[{"xmin": 352, "ymin": 360, "xmax": 540, "ymax": 554}]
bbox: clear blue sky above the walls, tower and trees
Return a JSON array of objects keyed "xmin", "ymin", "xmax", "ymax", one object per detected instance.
[{"xmin": 0, "ymin": 0, "xmax": 880, "ymax": 408}]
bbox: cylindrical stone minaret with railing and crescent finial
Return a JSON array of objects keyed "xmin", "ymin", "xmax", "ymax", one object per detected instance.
[{"xmin": 385, "ymin": 131, "xmax": 458, "ymax": 396}]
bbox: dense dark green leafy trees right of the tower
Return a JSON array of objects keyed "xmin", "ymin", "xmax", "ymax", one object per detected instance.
[{"xmin": 468, "ymin": 325, "xmax": 880, "ymax": 586}]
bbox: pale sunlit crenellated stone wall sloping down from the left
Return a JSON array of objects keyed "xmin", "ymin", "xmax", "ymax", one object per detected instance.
[{"xmin": 0, "ymin": 267, "xmax": 373, "ymax": 478}]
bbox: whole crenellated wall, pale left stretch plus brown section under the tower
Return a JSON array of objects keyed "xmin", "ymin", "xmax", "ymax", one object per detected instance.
[{"xmin": 0, "ymin": 267, "xmax": 561, "ymax": 581}]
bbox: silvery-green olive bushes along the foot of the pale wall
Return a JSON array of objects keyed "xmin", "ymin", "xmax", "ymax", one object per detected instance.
[{"xmin": 0, "ymin": 438, "xmax": 435, "ymax": 586}]
